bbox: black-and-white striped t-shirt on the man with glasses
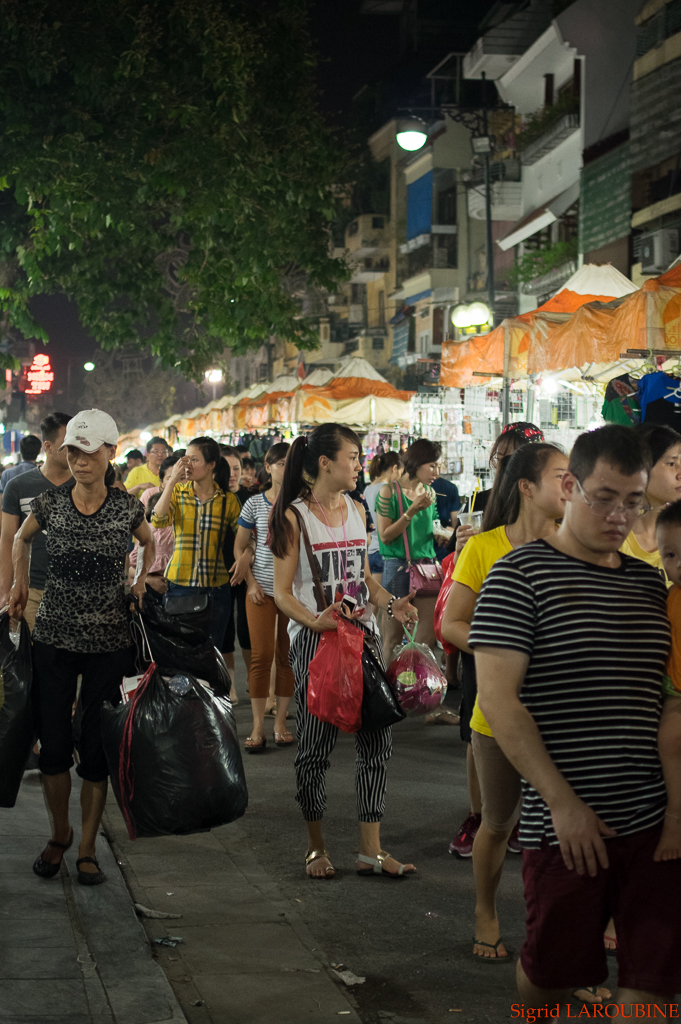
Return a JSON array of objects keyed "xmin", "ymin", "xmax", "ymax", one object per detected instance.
[{"xmin": 469, "ymin": 541, "xmax": 670, "ymax": 848}]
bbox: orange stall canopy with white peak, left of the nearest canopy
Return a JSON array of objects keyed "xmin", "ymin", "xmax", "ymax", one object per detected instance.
[{"xmin": 440, "ymin": 263, "xmax": 636, "ymax": 387}]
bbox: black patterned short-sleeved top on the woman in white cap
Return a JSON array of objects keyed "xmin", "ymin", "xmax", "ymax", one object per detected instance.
[{"xmin": 31, "ymin": 483, "xmax": 144, "ymax": 653}]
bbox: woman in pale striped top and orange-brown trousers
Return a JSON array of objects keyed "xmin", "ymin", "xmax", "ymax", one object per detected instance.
[{"xmin": 232, "ymin": 441, "xmax": 294, "ymax": 754}]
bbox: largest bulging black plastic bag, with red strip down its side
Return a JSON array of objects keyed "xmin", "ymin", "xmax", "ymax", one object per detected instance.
[{"xmin": 101, "ymin": 666, "xmax": 248, "ymax": 840}]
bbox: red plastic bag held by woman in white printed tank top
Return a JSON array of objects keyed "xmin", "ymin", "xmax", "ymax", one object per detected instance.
[{"xmin": 307, "ymin": 615, "xmax": 365, "ymax": 732}]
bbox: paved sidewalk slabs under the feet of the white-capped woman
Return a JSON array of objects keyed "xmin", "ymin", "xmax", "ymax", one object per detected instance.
[{"xmin": 0, "ymin": 772, "xmax": 185, "ymax": 1024}]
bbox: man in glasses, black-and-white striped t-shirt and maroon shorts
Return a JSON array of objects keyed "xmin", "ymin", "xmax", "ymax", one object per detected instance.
[{"xmin": 469, "ymin": 426, "xmax": 681, "ymax": 1019}]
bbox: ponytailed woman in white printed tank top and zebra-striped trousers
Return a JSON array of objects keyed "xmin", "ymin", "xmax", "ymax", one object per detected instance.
[{"xmin": 269, "ymin": 423, "xmax": 417, "ymax": 879}]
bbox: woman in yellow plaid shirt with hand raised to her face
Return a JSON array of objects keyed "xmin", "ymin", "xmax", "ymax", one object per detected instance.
[{"xmin": 152, "ymin": 437, "xmax": 241, "ymax": 651}]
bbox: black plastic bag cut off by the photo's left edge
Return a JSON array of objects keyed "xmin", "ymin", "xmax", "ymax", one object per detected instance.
[{"xmin": 0, "ymin": 611, "xmax": 35, "ymax": 807}]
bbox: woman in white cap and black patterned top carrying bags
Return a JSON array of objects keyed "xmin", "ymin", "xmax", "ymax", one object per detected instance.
[{"xmin": 9, "ymin": 409, "xmax": 154, "ymax": 886}]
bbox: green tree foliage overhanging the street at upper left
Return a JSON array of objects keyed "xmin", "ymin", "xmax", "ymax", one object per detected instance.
[{"xmin": 0, "ymin": 0, "xmax": 348, "ymax": 377}]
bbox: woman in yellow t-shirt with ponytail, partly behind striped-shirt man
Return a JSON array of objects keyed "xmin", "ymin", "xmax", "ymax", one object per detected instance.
[{"xmin": 442, "ymin": 443, "xmax": 567, "ymax": 962}]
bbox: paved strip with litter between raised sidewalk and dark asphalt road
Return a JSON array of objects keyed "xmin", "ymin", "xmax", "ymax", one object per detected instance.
[{"xmin": 105, "ymin": 801, "xmax": 359, "ymax": 1024}]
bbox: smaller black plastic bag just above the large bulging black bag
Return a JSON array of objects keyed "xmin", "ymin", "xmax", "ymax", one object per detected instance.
[{"xmin": 132, "ymin": 595, "xmax": 231, "ymax": 694}]
